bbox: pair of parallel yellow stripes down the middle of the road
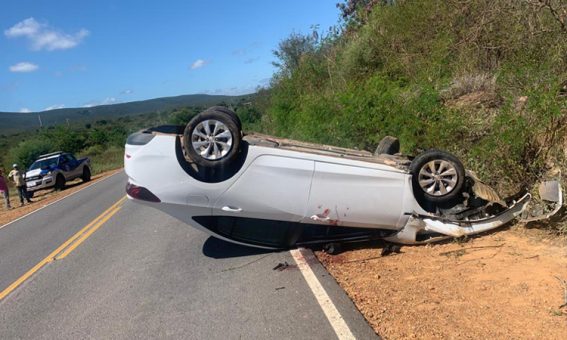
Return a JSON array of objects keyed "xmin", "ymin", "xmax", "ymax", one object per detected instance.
[{"xmin": 0, "ymin": 196, "xmax": 126, "ymax": 301}]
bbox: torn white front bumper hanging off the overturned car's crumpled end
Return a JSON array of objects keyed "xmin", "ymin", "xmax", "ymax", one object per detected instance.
[{"xmin": 386, "ymin": 194, "xmax": 531, "ymax": 244}]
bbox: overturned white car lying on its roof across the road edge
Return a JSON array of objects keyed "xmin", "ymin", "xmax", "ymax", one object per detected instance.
[{"xmin": 125, "ymin": 107, "xmax": 561, "ymax": 249}]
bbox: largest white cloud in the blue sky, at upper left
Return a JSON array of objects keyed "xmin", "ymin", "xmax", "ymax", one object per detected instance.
[{"xmin": 4, "ymin": 18, "xmax": 89, "ymax": 51}]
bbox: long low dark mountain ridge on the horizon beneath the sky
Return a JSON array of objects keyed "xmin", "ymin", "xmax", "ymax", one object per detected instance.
[{"xmin": 0, "ymin": 94, "xmax": 247, "ymax": 135}]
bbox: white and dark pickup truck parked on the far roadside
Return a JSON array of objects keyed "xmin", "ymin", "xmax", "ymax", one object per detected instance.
[{"xmin": 26, "ymin": 151, "xmax": 91, "ymax": 196}]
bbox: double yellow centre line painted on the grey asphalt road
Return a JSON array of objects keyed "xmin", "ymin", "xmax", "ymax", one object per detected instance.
[{"xmin": 0, "ymin": 196, "xmax": 126, "ymax": 301}]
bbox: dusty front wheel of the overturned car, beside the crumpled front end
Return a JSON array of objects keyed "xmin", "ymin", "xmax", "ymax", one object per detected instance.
[{"xmin": 410, "ymin": 150, "xmax": 465, "ymax": 204}]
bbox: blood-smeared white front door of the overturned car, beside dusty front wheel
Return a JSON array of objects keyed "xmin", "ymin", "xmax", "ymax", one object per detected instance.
[{"xmin": 303, "ymin": 162, "xmax": 408, "ymax": 229}]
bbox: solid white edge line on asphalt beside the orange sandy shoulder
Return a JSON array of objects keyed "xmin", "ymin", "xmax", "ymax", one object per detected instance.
[{"xmin": 289, "ymin": 248, "xmax": 356, "ymax": 340}]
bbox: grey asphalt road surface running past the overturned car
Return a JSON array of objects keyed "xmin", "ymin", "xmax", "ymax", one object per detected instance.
[{"xmin": 0, "ymin": 173, "xmax": 376, "ymax": 339}]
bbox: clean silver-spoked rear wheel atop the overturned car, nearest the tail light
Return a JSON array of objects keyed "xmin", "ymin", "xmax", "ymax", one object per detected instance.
[{"xmin": 183, "ymin": 109, "xmax": 242, "ymax": 167}]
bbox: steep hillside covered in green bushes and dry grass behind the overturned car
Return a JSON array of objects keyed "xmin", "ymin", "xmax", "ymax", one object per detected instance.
[{"xmin": 268, "ymin": 0, "xmax": 567, "ymax": 192}]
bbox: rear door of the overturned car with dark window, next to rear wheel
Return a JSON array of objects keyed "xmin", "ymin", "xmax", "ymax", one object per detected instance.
[{"xmin": 207, "ymin": 155, "xmax": 314, "ymax": 247}]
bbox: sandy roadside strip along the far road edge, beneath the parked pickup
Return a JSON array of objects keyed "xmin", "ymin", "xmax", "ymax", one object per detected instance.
[{"xmin": 0, "ymin": 169, "xmax": 122, "ymax": 227}]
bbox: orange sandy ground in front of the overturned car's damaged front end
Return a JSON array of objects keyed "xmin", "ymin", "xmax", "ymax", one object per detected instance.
[{"xmin": 317, "ymin": 227, "xmax": 567, "ymax": 339}]
